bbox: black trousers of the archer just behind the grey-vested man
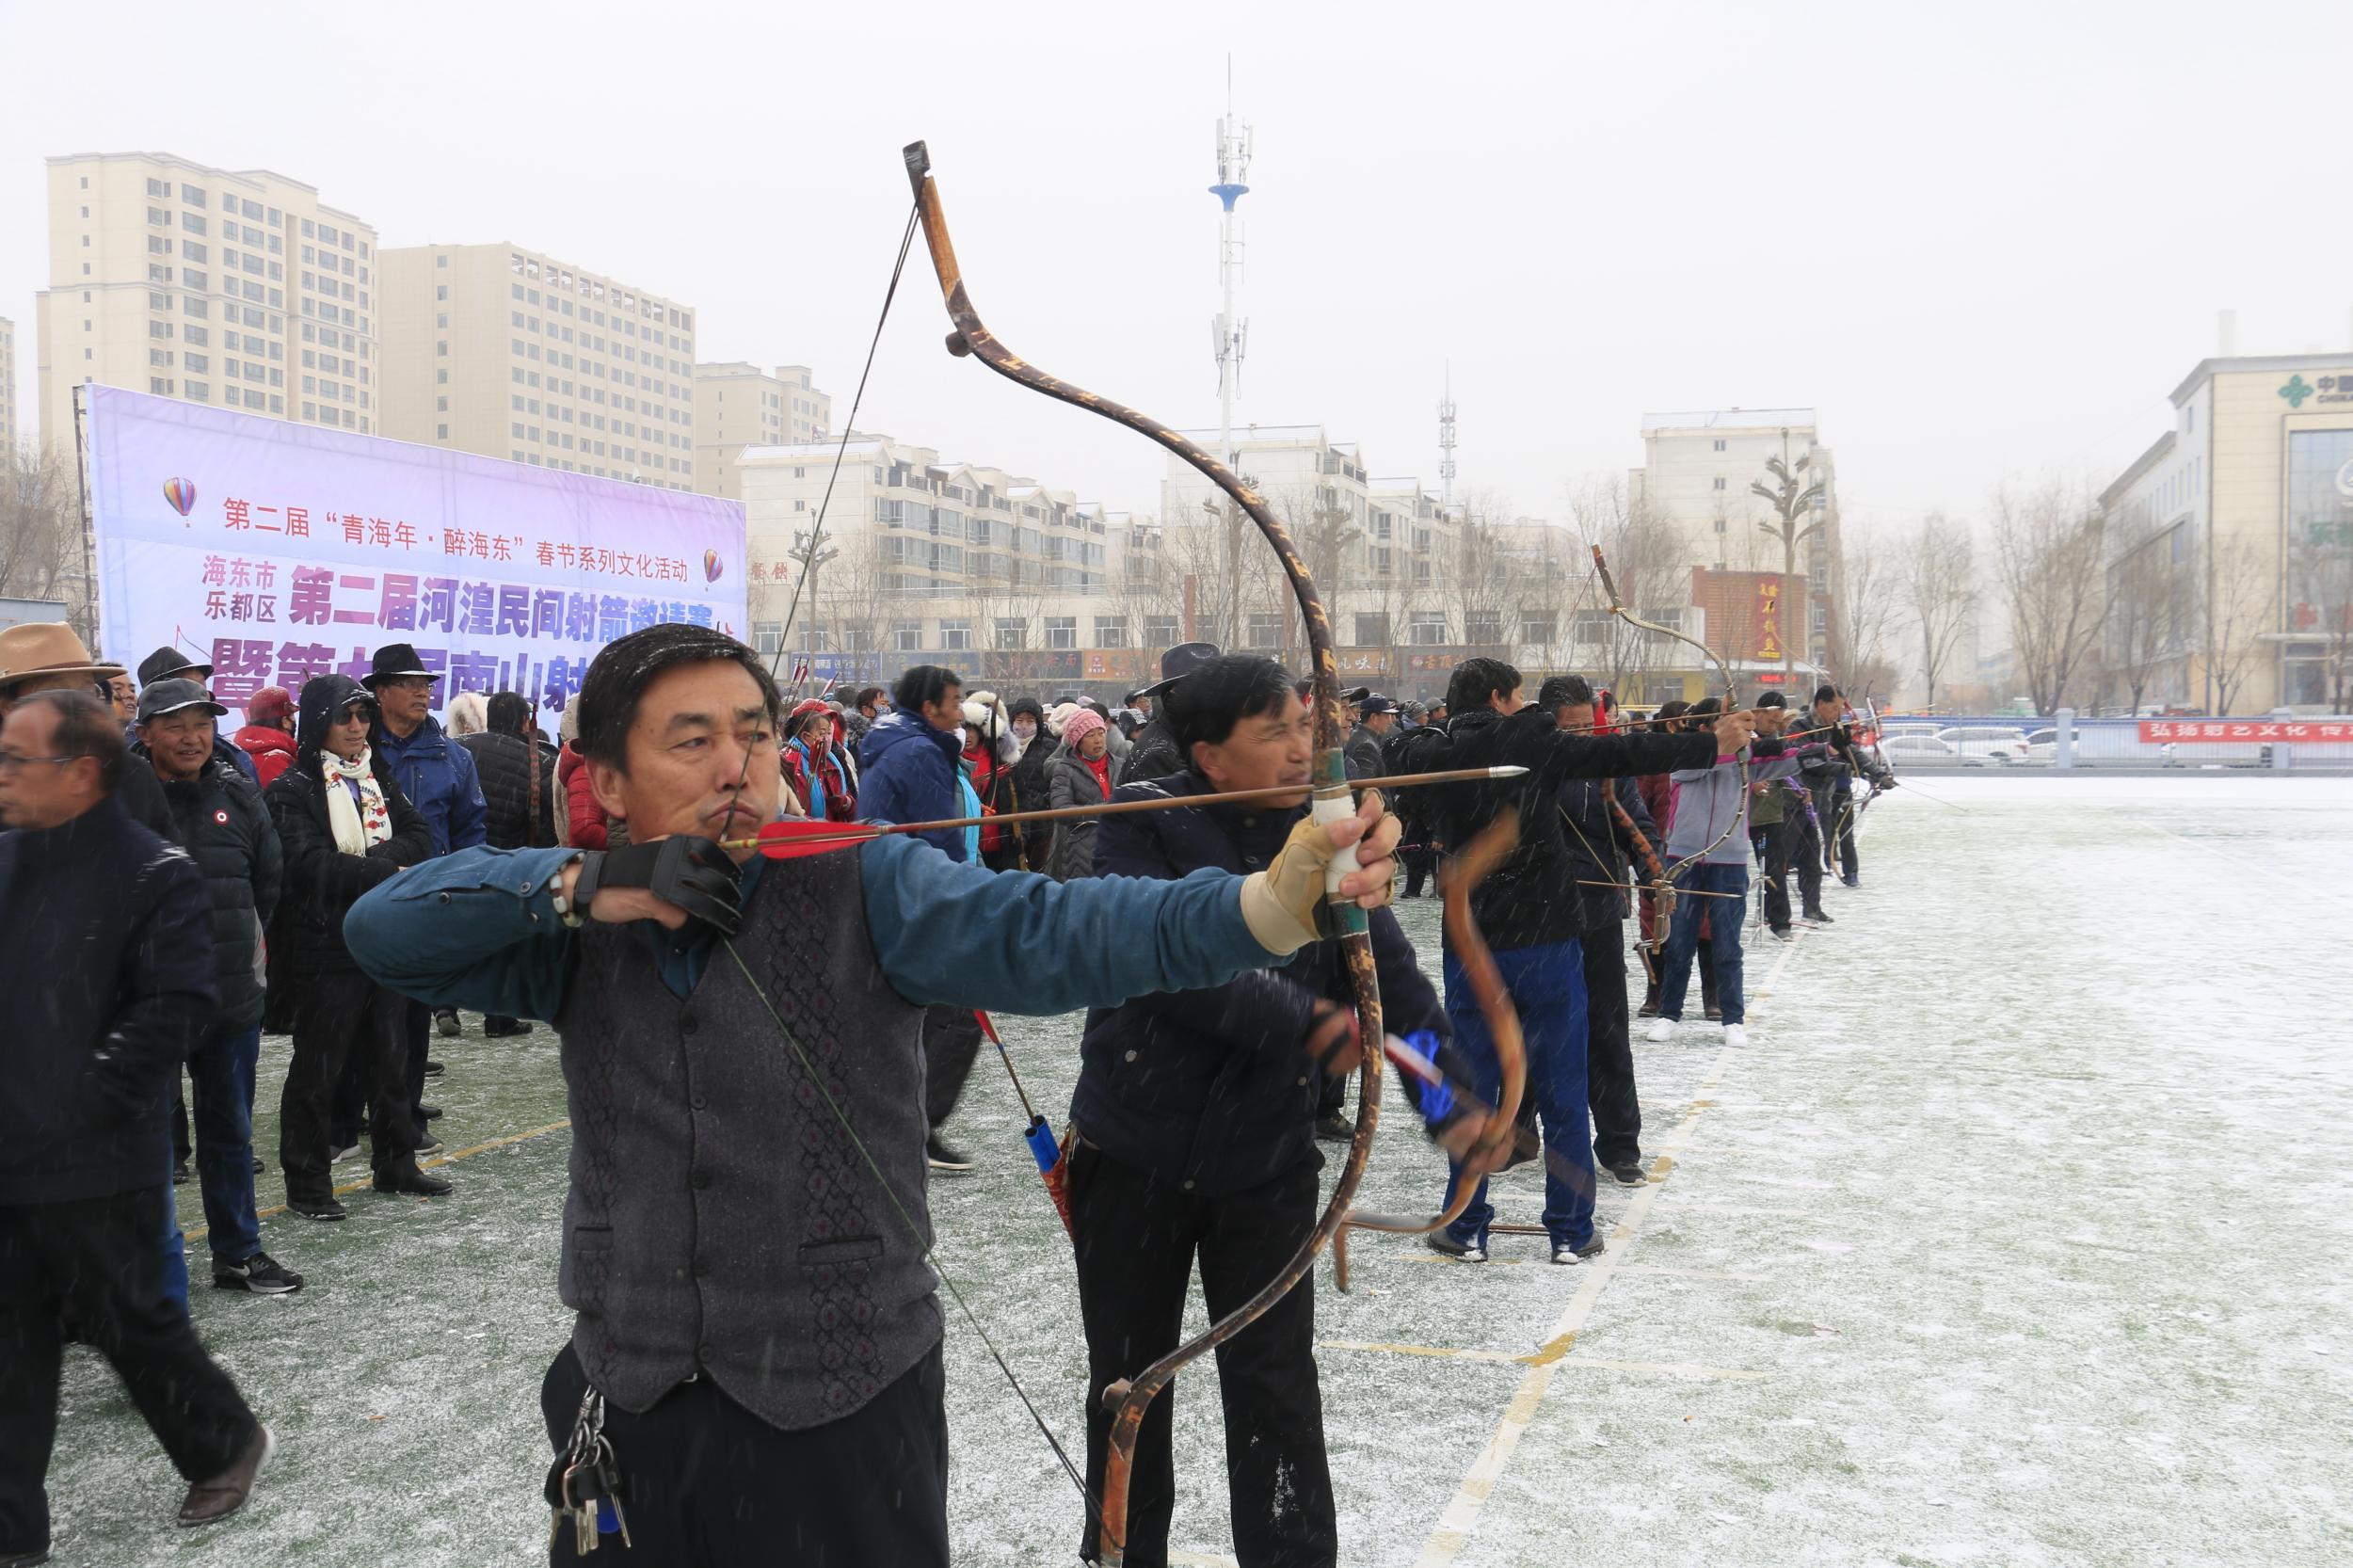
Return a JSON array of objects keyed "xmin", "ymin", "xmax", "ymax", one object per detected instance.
[{"xmin": 1071, "ymin": 1142, "xmax": 1339, "ymax": 1568}]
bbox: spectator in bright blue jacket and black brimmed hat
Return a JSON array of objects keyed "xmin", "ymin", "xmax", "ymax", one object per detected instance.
[{"xmin": 358, "ymin": 643, "xmax": 489, "ymax": 1154}]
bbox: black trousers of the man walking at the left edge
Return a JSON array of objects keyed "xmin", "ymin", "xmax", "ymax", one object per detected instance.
[{"xmin": 0, "ymin": 1187, "xmax": 254, "ymax": 1559}]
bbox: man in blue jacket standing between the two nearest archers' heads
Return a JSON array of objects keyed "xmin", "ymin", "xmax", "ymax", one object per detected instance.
[{"xmin": 859, "ymin": 664, "xmax": 982, "ymax": 1170}]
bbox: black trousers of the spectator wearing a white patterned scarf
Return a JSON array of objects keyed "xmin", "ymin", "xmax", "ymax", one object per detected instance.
[{"xmin": 278, "ymin": 970, "xmax": 417, "ymax": 1203}]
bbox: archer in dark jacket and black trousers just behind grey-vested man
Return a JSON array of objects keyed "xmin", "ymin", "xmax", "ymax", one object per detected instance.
[{"xmin": 1071, "ymin": 654, "xmax": 1448, "ymax": 1563}]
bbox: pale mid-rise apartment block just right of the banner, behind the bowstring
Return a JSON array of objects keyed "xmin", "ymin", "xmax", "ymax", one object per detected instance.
[{"xmin": 737, "ymin": 436, "xmax": 1148, "ymax": 696}]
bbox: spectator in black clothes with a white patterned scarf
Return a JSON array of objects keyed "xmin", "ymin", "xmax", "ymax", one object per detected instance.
[{"xmin": 266, "ymin": 676, "xmax": 450, "ymax": 1220}]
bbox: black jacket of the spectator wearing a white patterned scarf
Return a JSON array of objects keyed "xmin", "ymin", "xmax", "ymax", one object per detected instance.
[{"xmin": 264, "ymin": 676, "xmax": 438, "ymax": 984}]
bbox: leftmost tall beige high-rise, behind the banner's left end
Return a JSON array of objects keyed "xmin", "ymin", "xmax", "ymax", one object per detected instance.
[{"xmin": 38, "ymin": 153, "xmax": 381, "ymax": 452}]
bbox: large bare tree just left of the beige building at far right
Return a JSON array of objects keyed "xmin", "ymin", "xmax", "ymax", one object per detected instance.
[{"xmin": 1993, "ymin": 480, "xmax": 2108, "ymax": 713}]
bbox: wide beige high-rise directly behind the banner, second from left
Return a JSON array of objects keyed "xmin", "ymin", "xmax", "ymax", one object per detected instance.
[{"xmin": 381, "ymin": 243, "xmax": 695, "ymax": 489}]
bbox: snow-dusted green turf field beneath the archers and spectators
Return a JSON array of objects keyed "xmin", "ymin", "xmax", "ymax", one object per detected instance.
[{"xmin": 37, "ymin": 776, "xmax": 2353, "ymax": 1568}]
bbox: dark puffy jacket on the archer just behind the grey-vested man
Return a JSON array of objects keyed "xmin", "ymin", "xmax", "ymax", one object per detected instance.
[{"xmin": 1071, "ymin": 770, "xmax": 1457, "ymax": 1196}]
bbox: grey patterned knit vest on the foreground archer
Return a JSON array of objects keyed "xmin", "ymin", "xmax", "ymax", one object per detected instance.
[{"xmin": 555, "ymin": 853, "xmax": 941, "ymax": 1429}]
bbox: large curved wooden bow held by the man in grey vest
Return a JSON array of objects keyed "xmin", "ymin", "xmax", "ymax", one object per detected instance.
[{"xmin": 906, "ymin": 141, "xmax": 1382, "ymax": 1565}]
